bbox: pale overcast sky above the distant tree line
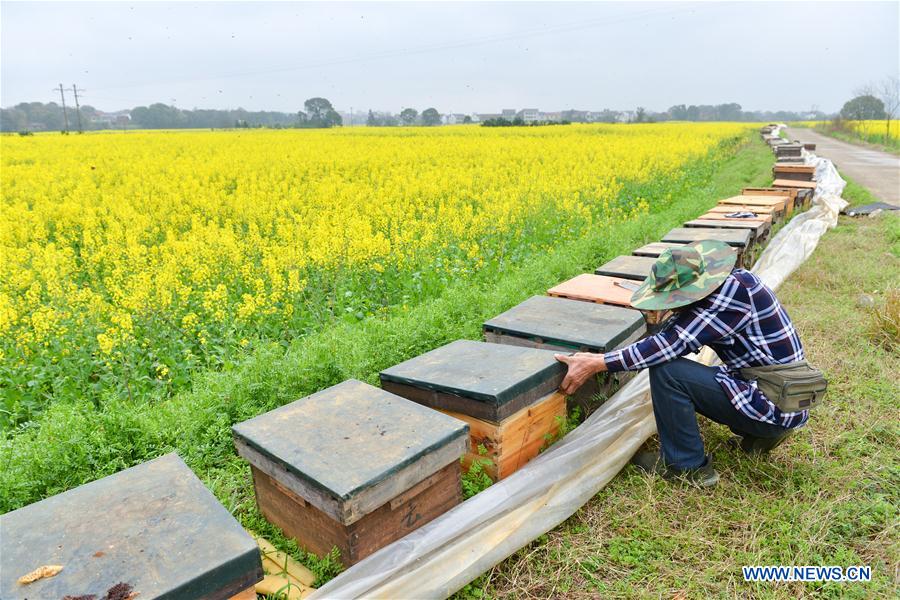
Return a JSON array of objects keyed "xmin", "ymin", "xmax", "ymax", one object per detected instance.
[{"xmin": 0, "ymin": 1, "xmax": 900, "ymax": 112}]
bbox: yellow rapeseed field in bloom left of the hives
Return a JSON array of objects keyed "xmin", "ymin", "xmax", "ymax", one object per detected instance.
[{"xmin": 0, "ymin": 124, "xmax": 747, "ymax": 422}]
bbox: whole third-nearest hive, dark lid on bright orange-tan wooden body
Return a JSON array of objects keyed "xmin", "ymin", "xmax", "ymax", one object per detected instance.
[{"xmin": 381, "ymin": 340, "xmax": 566, "ymax": 480}]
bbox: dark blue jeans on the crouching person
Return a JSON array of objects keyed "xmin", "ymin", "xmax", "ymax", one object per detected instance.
[{"xmin": 650, "ymin": 358, "xmax": 788, "ymax": 469}]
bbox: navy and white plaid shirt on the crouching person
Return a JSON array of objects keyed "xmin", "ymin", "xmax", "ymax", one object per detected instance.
[{"xmin": 604, "ymin": 269, "xmax": 809, "ymax": 428}]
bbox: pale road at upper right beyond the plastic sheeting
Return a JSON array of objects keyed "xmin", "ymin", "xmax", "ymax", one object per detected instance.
[{"xmin": 787, "ymin": 128, "xmax": 900, "ymax": 206}]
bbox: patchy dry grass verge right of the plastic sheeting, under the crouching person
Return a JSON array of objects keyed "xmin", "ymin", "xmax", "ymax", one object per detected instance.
[{"xmin": 458, "ymin": 185, "xmax": 900, "ymax": 598}]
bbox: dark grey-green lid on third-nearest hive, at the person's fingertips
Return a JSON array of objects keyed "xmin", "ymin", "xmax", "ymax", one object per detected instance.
[{"xmin": 381, "ymin": 340, "xmax": 566, "ymax": 416}]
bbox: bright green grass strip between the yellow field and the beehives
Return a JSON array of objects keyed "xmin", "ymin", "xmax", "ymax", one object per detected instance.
[{"xmin": 0, "ymin": 134, "xmax": 773, "ymax": 580}]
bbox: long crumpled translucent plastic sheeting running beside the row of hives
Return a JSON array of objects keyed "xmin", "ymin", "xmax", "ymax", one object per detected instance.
[{"xmin": 309, "ymin": 134, "xmax": 846, "ymax": 599}]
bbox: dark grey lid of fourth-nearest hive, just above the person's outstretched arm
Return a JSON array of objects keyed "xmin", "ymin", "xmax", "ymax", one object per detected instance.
[{"xmin": 484, "ymin": 296, "xmax": 646, "ymax": 352}]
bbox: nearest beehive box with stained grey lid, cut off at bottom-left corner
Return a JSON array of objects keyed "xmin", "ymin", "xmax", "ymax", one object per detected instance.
[{"xmin": 0, "ymin": 453, "xmax": 263, "ymax": 600}]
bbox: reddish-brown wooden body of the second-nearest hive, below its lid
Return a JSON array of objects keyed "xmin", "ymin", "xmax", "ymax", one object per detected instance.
[{"xmin": 251, "ymin": 460, "xmax": 462, "ymax": 566}]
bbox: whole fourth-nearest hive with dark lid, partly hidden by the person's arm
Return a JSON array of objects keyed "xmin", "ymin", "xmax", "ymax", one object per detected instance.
[{"xmin": 483, "ymin": 294, "xmax": 653, "ymax": 414}]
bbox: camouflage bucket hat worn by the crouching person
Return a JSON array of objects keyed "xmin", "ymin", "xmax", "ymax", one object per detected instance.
[{"xmin": 631, "ymin": 240, "xmax": 737, "ymax": 310}]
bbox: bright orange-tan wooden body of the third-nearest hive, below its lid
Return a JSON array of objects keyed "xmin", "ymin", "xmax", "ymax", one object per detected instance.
[{"xmin": 447, "ymin": 392, "xmax": 566, "ymax": 481}]
